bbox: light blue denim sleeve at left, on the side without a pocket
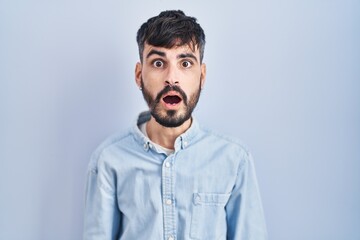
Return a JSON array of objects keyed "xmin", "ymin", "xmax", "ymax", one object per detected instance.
[{"xmin": 83, "ymin": 164, "xmax": 120, "ymax": 240}]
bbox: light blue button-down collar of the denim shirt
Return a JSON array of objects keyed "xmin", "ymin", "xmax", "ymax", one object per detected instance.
[{"xmin": 133, "ymin": 111, "xmax": 200, "ymax": 152}]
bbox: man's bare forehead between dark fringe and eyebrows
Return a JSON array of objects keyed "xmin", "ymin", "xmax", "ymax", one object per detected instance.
[{"xmin": 143, "ymin": 43, "xmax": 200, "ymax": 59}]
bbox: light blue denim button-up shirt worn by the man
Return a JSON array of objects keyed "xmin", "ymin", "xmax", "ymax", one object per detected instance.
[{"xmin": 84, "ymin": 111, "xmax": 267, "ymax": 240}]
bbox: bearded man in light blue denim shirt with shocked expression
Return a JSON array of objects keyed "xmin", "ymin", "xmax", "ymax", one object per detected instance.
[{"xmin": 84, "ymin": 11, "xmax": 267, "ymax": 240}]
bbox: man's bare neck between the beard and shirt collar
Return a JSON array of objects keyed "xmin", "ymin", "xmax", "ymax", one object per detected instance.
[{"xmin": 146, "ymin": 117, "xmax": 192, "ymax": 149}]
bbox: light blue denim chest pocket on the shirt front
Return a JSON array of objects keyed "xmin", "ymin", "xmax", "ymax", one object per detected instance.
[{"xmin": 190, "ymin": 193, "xmax": 230, "ymax": 240}]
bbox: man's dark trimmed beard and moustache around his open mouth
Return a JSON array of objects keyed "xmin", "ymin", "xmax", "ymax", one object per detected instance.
[{"xmin": 141, "ymin": 79, "xmax": 201, "ymax": 128}]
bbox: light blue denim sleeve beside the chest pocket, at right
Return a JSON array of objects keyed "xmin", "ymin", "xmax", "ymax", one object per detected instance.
[{"xmin": 226, "ymin": 153, "xmax": 268, "ymax": 240}]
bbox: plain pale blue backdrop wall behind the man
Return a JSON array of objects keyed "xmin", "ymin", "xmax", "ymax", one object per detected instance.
[{"xmin": 0, "ymin": 0, "xmax": 360, "ymax": 240}]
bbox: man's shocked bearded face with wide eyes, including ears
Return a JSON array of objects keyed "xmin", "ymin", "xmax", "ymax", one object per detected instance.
[{"xmin": 135, "ymin": 44, "xmax": 206, "ymax": 127}]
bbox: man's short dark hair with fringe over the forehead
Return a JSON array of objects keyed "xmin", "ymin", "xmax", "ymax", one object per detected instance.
[{"xmin": 136, "ymin": 10, "xmax": 205, "ymax": 62}]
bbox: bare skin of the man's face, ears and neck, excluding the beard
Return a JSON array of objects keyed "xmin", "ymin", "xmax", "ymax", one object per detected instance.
[{"xmin": 135, "ymin": 44, "xmax": 206, "ymax": 149}]
